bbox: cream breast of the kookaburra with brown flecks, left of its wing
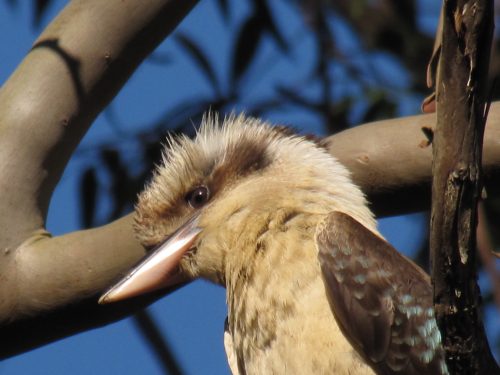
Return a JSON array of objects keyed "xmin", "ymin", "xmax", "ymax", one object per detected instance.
[{"xmin": 226, "ymin": 208, "xmax": 373, "ymax": 374}]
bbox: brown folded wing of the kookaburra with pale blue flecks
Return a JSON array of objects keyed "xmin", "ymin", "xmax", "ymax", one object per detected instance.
[{"xmin": 316, "ymin": 212, "xmax": 447, "ymax": 375}]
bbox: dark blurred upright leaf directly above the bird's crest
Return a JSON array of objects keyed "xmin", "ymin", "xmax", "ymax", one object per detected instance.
[{"xmin": 231, "ymin": 14, "xmax": 264, "ymax": 92}]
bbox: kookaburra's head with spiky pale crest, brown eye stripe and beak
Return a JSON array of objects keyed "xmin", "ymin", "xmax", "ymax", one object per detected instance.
[{"xmin": 100, "ymin": 115, "xmax": 375, "ymax": 302}]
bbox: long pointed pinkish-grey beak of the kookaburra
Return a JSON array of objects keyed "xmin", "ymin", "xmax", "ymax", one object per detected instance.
[{"xmin": 99, "ymin": 216, "xmax": 201, "ymax": 304}]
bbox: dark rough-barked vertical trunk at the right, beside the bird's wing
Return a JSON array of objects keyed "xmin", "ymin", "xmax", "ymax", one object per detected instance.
[{"xmin": 430, "ymin": 0, "xmax": 498, "ymax": 375}]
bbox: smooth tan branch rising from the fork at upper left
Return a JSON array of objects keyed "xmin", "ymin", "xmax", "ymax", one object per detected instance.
[{"xmin": 0, "ymin": 0, "xmax": 196, "ymax": 253}]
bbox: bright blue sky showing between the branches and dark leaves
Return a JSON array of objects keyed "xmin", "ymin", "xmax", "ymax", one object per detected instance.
[{"xmin": 5, "ymin": 0, "xmax": 494, "ymax": 375}]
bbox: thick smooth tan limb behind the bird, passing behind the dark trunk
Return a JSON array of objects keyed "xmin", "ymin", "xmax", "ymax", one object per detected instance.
[{"xmin": 327, "ymin": 103, "xmax": 500, "ymax": 216}]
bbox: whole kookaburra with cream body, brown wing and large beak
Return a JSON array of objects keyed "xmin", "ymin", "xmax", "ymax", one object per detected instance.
[{"xmin": 99, "ymin": 113, "xmax": 448, "ymax": 375}]
